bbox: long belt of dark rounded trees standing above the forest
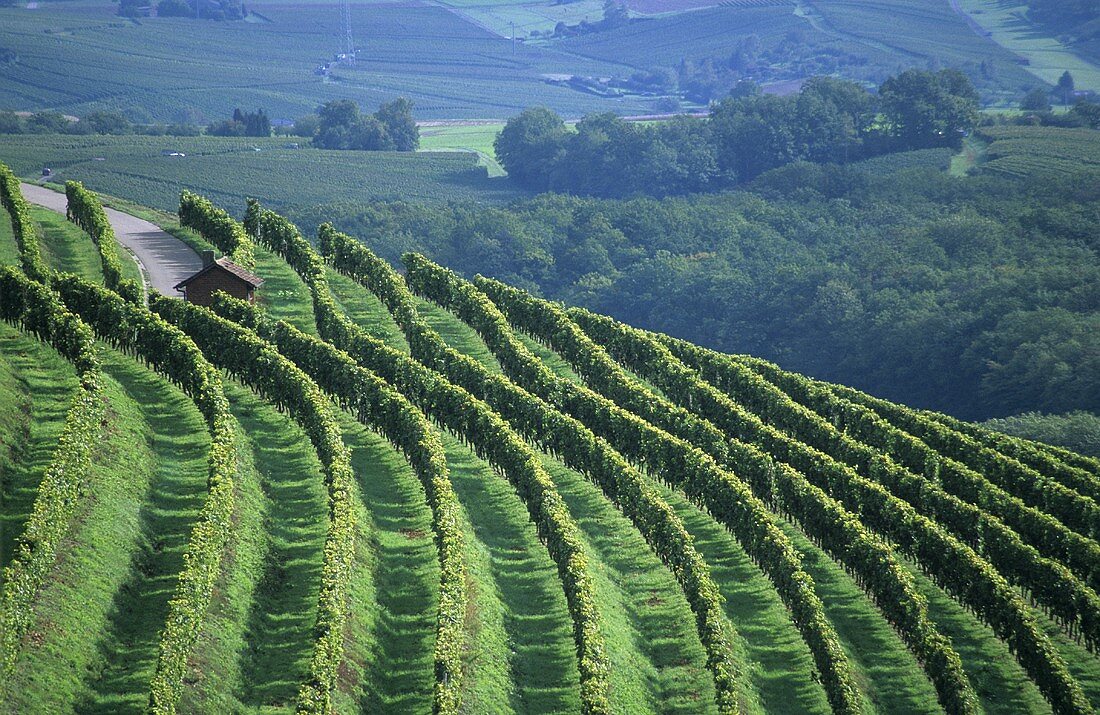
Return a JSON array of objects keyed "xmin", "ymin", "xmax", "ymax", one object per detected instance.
[{"xmin": 495, "ymin": 70, "xmax": 978, "ymax": 197}]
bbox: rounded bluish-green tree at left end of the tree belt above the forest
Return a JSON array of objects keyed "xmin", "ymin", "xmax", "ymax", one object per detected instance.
[{"xmin": 493, "ymin": 107, "xmax": 568, "ymax": 189}]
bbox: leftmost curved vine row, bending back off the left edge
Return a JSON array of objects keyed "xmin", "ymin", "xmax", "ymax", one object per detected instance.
[{"xmin": 0, "ymin": 266, "xmax": 107, "ymax": 677}]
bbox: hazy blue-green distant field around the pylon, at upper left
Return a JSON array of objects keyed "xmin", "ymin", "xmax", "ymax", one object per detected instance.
[{"xmin": 0, "ymin": 0, "xmax": 649, "ymax": 123}]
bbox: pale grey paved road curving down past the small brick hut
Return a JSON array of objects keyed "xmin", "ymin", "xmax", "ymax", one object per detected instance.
[{"xmin": 20, "ymin": 184, "xmax": 202, "ymax": 297}]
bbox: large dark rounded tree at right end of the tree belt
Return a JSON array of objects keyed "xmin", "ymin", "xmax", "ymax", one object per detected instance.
[{"xmin": 879, "ymin": 69, "xmax": 978, "ymax": 150}]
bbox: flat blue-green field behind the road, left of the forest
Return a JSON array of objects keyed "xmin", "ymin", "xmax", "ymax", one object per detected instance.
[{"xmin": 0, "ymin": 133, "xmax": 525, "ymax": 211}]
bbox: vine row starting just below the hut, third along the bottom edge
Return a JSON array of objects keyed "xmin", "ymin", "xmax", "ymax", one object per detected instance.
[{"xmin": 206, "ymin": 294, "xmax": 468, "ymax": 715}]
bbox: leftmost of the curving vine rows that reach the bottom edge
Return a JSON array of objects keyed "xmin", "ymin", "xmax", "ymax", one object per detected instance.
[{"xmin": 54, "ymin": 275, "xmax": 238, "ymax": 713}]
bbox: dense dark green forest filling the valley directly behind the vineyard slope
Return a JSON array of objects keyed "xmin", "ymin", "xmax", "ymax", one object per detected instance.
[{"xmin": 295, "ymin": 150, "xmax": 1100, "ymax": 418}]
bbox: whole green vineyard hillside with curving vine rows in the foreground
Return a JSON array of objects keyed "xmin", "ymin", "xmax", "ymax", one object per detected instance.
[{"xmin": 0, "ymin": 168, "xmax": 1100, "ymax": 713}]
